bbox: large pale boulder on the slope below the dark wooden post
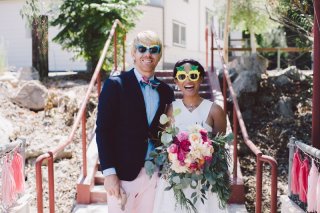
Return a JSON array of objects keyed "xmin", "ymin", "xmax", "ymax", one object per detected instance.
[{"xmin": 10, "ymin": 81, "xmax": 48, "ymax": 111}]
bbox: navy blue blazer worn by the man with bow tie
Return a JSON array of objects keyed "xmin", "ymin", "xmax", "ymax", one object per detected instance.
[{"xmin": 96, "ymin": 69, "xmax": 174, "ymax": 181}]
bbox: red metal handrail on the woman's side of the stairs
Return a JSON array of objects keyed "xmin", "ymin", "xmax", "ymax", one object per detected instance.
[{"xmin": 206, "ymin": 27, "xmax": 278, "ymax": 213}]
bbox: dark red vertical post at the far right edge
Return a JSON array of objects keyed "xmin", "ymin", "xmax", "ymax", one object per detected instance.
[{"xmin": 312, "ymin": 0, "xmax": 320, "ymax": 149}]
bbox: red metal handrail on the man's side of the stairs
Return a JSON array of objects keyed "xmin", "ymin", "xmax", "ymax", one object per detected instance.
[{"xmin": 36, "ymin": 20, "xmax": 125, "ymax": 213}]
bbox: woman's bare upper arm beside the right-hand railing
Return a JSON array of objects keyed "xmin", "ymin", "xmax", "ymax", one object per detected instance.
[{"xmin": 210, "ymin": 104, "xmax": 227, "ymax": 134}]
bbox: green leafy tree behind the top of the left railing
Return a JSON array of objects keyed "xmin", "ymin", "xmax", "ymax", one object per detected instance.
[{"xmin": 51, "ymin": 0, "xmax": 145, "ymax": 71}]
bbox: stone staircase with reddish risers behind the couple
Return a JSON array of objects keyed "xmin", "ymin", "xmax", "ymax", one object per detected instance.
[{"xmin": 73, "ymin": 70, "xmax": 246, "ymax": 213}]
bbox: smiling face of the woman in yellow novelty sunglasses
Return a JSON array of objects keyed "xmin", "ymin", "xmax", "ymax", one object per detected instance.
[{"xmin": 174, "ymin": 63, "xmax": 202, "ymax": 96}]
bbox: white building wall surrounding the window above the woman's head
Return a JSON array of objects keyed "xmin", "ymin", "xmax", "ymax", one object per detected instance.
[{"xmin": 164, "ymin": 0, "xmax": 213, "ymax": 67}]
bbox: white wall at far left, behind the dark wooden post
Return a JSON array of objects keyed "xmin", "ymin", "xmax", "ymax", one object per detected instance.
[{"xmin": 0, "ymin": 0, "xmax": 86, "ymax": 71}]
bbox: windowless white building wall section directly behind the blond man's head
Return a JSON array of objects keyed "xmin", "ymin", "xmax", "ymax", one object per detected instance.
[{"xmin": 126, "ymin": 6, "xmax": 164, "ymax": 70}]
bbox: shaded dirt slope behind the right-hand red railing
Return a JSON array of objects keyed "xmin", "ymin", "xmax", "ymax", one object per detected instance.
[{"xmin": 239, "ymin": 70, "xmax": 312, "ymax": 212}]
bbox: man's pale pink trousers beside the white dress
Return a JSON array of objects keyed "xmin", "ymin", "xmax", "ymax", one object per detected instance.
[{"xmin": 108, "ymin": 168, "xmax": 158, "ymax": 213}]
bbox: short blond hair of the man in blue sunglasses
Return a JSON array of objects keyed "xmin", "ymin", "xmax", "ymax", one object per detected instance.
[{"xmin": 131, "ymin": 30, "xmax": 162, "ymax": 56}]
